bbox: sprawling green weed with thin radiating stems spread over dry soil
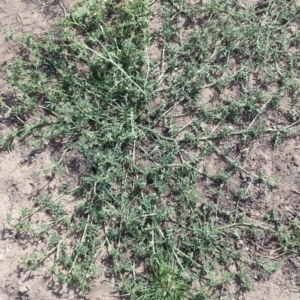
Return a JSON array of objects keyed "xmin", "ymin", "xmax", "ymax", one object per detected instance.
[{"xmin": 1, "ymin": 0, "xmax": 300, "ymax": 300}]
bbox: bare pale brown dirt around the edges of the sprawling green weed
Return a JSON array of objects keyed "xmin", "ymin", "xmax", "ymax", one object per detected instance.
[{"xmin": 0, "ymin": 0, "xmax": 300, "ymax": 300}]
